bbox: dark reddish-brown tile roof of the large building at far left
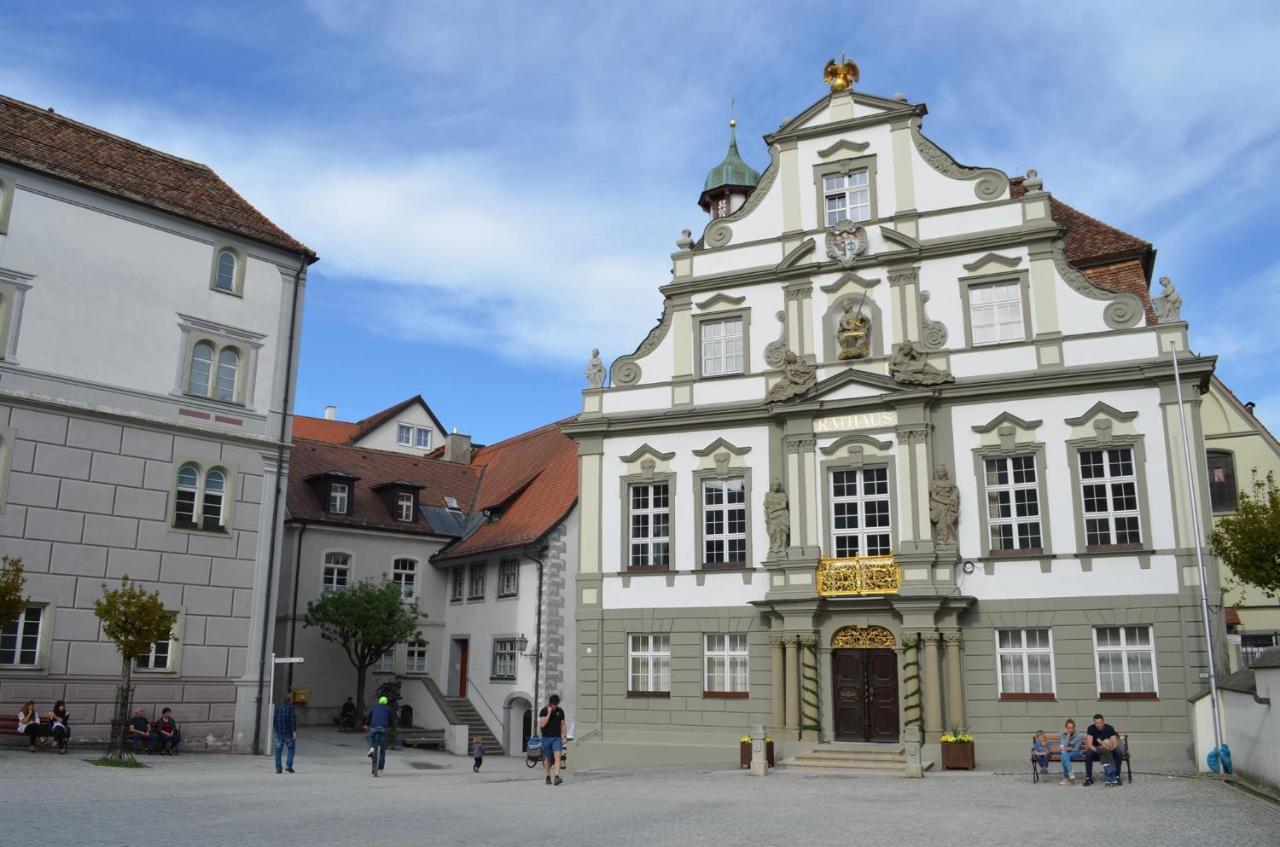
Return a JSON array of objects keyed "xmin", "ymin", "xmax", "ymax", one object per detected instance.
[{"xmin": 0, "ymin": 95, "xmax": 315, "ymax": 261}]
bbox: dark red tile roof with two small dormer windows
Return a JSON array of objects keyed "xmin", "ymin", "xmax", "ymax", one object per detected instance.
[{"xmin": 288, "ymin": 440, "xmax": 480, "ymax": 535}]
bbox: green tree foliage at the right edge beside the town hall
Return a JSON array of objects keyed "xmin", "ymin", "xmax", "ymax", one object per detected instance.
[{"xmin": 1208, "ymin": 472, "xmax": 1280, "ymax": 598}]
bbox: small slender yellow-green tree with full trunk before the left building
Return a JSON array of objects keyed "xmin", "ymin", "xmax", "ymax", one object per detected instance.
[{"xmin": 93, "ymin": 577, "xmax": 173, "ymax": 760}]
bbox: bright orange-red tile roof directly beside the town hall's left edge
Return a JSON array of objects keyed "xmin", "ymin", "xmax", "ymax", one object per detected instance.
[{"xmin": 435, "ymin": 418, "xmax": 577, "ymax": 560}]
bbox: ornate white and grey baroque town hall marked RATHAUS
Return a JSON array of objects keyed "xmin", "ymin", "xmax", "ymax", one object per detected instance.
[{"xmin": 564, "ymin": 65, "xmax": 1217, "ymax": 761}]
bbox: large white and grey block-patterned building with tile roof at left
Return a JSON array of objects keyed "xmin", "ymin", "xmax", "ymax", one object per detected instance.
[{"xmin": 0, "ymin": 97, "xmax": 316, "ymax": 750}]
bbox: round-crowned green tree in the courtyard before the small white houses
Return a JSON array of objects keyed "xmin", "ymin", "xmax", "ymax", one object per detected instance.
[{"xmin": 302, "ymin": 580, "xmax": 426, "ymax": 709}]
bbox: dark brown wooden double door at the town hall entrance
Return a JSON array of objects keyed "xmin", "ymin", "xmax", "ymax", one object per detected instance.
[{"xmin": 831, "ymin": 650, "xmax": 899, "ymax": 741}]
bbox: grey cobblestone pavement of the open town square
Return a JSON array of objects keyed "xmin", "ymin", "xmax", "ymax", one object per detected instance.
[{"xmin": 0, "ymin": 732, "xmax": 1280, "ymax": 847}]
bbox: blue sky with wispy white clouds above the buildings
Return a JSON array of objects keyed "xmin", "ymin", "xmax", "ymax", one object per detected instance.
[{"xmin": 0, "ymin": 0, "xmax": 1280, "ymax": 441}]
